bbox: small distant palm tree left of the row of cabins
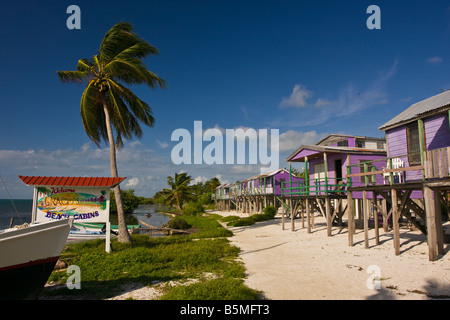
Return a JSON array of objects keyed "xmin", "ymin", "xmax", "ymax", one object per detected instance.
[{"xmin": 158, "ymin": 172, "xmax": 194, "ymax": 212}]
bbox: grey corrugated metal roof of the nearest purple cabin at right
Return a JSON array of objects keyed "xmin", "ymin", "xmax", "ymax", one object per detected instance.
[{"xmin": 378, "ymin": 91, "xmax": 450, "ymax": 131}]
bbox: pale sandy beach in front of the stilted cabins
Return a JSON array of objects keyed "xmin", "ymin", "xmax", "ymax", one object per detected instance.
[{"xmin": 214, "ymin": 211, "xmax": 450, "ymax": 300}]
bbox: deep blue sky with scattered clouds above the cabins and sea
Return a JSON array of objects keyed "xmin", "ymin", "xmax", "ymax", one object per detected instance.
[{"xmin": 0, "ymin": 0, "xmax": 450, "ymax": 198}]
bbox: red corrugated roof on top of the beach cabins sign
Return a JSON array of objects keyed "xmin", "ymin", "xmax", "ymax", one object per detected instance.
[{"xmin": 19, "ymin": 176, "xmax": 126, "ymax": 188}]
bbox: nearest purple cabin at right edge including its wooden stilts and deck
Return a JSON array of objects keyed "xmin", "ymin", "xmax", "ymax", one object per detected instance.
[{"xmin": 346, "ymin": 91, "xmax": 450, "ymax": 261}]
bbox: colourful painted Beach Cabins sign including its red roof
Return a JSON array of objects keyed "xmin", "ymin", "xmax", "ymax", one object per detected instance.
[{"xmin": 19, "ymin": 176, "xmax": 125, "ymax": 223}]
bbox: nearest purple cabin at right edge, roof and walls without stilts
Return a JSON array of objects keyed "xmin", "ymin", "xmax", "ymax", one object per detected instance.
[{"xmin": 379, "ymin": 91, "xmax": 450, "ymax": 185}]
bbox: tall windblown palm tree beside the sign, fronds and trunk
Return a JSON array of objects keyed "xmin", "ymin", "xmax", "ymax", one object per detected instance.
[{"xmin": 57, "ymin": 22, "xmax": 166, "ymax": 242}]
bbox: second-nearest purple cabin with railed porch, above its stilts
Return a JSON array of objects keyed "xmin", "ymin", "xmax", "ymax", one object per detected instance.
[{"xmin": 282, "ymin": 134, "xmax": 386, "ymax": 198}]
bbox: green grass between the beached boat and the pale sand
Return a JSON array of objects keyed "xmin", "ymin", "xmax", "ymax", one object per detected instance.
[{"xmin": 43, "ymin": 212, "xmax": 259, "ymax": 300}]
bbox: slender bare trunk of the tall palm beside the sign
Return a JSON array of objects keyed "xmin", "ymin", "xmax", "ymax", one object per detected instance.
[{"xmin": 103, "ymin": 100, "xmax": 131, "ymax": 242}]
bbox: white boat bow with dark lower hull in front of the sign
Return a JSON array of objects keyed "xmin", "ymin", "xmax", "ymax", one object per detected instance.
[{"xmin": 0, "ymin": 218, "xmax": 73, "ymax": 300}]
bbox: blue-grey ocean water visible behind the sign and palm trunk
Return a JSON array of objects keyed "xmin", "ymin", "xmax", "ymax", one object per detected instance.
[{"xmin": 0, "ymin": 199, "xmax": 170, "ymax": 229}]
